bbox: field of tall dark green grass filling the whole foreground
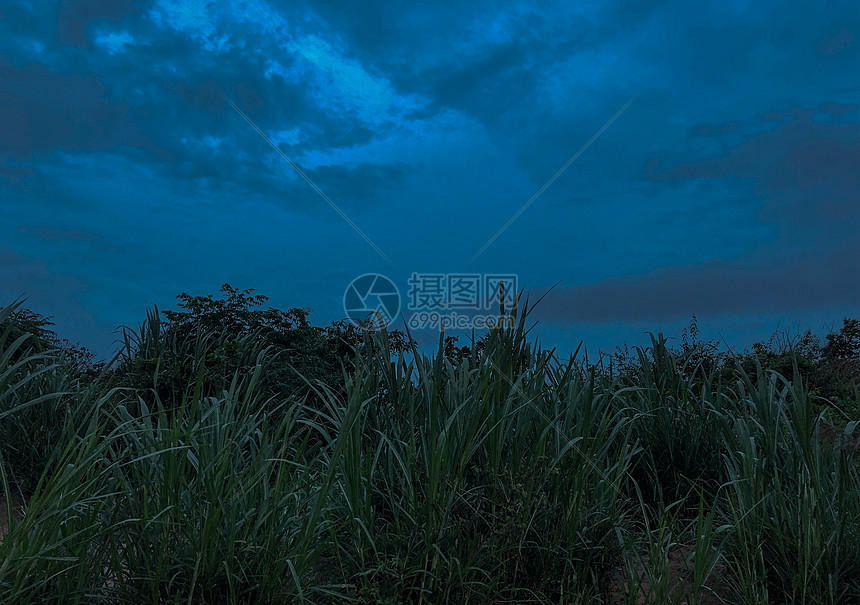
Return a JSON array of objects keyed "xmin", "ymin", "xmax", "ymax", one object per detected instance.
[{"xmin": 0, "ymin": 300, "xmax": 860, "ymax": 605}]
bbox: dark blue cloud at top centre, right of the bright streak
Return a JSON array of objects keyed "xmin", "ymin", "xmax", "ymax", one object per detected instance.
[{"xmin": 286, "ymin": 1, "xmax": 608, "ymax": 138}]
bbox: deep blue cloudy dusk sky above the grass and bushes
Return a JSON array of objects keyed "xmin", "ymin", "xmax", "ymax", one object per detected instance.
[{"xmin": 0, "ymin": 0, "xmax": 860, "ymax": 356}]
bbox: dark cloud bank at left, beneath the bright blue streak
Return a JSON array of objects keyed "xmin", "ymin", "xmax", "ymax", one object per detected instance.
[{"xmin": 0, "ymin": 28, "xmax": 402, "ymax": 215}]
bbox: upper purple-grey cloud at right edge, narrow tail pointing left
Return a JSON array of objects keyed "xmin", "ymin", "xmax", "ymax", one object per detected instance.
[{"xmin": 643, "ymin": 103, "xmax": 860, "ymax": 247}]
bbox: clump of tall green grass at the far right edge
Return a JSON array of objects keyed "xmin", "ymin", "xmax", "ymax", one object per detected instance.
[{"xmin": 725, "ymin": 368, "xmax": 860, "ymax": 603}]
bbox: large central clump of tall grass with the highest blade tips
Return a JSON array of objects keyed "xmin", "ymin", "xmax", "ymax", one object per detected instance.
[{"xmin": 322, "ymin": 314, "xmax": 632, "ymax": 603}]
